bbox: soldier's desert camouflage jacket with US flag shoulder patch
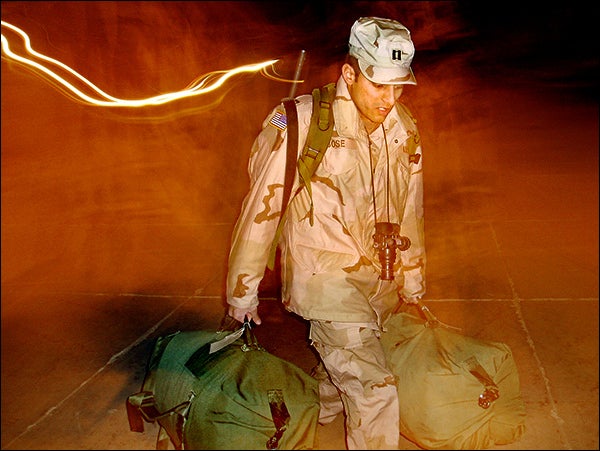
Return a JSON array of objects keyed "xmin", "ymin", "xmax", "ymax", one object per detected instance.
[{"xmin": 227, "ymin": 77, "xmax": 426, "ymax": 324}]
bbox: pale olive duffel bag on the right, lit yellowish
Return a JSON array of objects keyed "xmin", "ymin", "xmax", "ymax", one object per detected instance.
[{"xmin": 381, "ymin": 304, "xmax": 525, "ymax": 450}]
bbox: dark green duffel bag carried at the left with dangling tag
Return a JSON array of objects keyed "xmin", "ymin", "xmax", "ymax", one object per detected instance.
[{"xmin": 127, "ymin": 320, "xmax": 320, "ymax": 449}]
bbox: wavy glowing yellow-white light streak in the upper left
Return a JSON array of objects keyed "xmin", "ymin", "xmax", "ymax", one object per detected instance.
[{"xmin": 2, "ymin": 21, "xmax": 294, "ymax": 108}]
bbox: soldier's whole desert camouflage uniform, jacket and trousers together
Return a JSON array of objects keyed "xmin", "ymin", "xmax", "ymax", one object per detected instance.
[{"xmin": 227, "ymin": 77, "xmax": 425, "ymax": 449}]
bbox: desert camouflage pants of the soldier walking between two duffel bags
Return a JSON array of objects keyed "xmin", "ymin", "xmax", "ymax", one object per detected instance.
[{"xmin": 310, "ymin": 321, "xmax": 400, "ymax": 449}]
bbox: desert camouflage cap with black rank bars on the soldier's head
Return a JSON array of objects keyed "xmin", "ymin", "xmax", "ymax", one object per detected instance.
[{"xmin": 348, "ymin": 17, "xmax": 417, "ymax": 85}]
